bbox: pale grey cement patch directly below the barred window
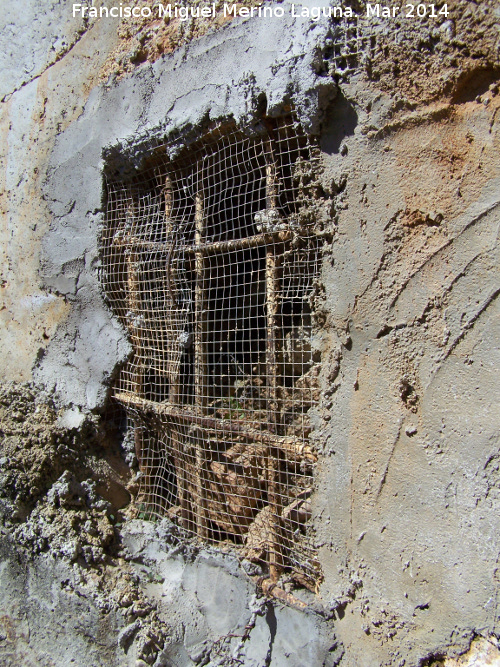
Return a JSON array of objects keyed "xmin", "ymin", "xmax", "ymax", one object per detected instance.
[{"xmin": 118, "ymin": 520, "xmax": 342, "ymax": 667}]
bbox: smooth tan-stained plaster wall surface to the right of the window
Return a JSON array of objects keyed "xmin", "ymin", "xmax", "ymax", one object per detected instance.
[{"xmin": 316, "ymin": 78, "xmax": 500, "ymax": 665}]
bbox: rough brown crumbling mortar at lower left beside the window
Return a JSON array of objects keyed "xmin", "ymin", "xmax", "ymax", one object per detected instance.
[{"xmin": 0, "ymin": 384, "xmax": 174, "ymax": 664}]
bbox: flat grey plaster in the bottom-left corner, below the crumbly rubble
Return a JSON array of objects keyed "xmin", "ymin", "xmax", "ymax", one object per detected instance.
[{"xmin": 0, "ymin": 535, "xmax": 121, "ymax": 667}]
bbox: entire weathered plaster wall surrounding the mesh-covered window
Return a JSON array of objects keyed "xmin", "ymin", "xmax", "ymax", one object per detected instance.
[{"xmin": 0, "ymin": 1, "xmax": 500, "ymax": 667}]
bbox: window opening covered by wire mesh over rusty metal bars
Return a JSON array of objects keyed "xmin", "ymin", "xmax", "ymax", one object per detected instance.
[{"xmin": 102, "ymin": 114, "xmax": 323, "ymax": 588}]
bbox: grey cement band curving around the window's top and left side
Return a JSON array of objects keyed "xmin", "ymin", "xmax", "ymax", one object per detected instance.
[{"xmin": 35, "ymin": 17, "xmax": 336, "ymax": 409}]
